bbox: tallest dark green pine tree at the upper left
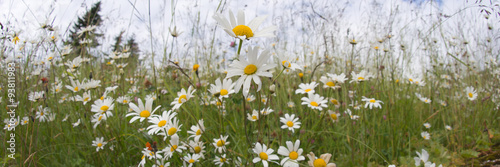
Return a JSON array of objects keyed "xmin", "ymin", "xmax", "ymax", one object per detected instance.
[{"xmin": 65, "ymin": 1, "xmax": 102, "ymax": 55}]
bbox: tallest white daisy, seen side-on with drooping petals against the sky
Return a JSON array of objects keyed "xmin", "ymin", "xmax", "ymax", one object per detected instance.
[{"xmin": 212, "ymin": 10, "xmax": 277, "ymax": 40}]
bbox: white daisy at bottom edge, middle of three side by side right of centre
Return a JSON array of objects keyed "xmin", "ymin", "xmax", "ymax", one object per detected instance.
[{"xmin": 278, "ymin": 140, "xmax": 306, "ymax": 167}]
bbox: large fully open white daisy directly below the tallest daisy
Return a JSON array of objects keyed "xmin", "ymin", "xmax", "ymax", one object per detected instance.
[{"xmin": 226, "ymin": 47, "xmax": 275, "ymax": 97}]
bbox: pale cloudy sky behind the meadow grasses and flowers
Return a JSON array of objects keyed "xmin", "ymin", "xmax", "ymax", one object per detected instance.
[{"xmin": 0, "ymin": 0, "xmax": 499, "ymax": 73}]
